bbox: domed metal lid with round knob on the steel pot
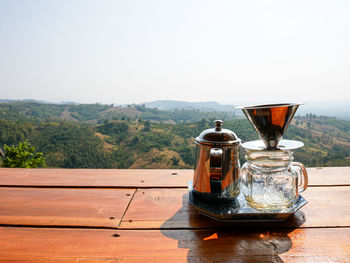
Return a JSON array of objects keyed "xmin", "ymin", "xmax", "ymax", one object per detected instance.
[{"xmin": 196, "ymin": 120, "xmax": 241, "ymax": 146}]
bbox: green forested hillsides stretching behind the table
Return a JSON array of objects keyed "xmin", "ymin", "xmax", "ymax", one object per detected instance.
[{"xmin": 0, "ymin": 102, "xmax": 350, "ymax": 168}]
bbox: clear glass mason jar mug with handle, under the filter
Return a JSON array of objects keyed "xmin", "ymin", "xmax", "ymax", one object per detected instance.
[{"xmin": 241, "ymin": 149, "xmax": 308, "ymax": 210}]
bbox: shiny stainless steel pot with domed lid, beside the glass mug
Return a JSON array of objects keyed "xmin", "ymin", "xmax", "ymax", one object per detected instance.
[{"xmin": 193, "ymin": 120, "xmax": 241, "ymax": 199}]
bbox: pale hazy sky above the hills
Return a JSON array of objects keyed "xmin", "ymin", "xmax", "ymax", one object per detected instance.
[{"xmin": 0, "ymin": 0, "xmax": 350, "ymax": 104}]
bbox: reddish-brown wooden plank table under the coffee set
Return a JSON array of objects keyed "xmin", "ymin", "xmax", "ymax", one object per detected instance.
[{"xmin": 0, "ymin": 167, "xmax": 350, "ymax": 263}]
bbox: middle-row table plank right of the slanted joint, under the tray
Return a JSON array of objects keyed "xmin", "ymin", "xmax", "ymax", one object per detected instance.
[{"xmin": 120, "ymin": 186, "xmax": 350, "ymax": 229}]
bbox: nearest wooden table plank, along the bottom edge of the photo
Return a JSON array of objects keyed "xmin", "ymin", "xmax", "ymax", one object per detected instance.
[{"xmin": 0, "ymin": 227, "xmax": 350, "ymax": 263}]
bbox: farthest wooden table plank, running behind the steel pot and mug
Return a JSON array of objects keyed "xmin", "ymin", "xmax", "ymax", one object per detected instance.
[{"xmin": 0, "ymin": 167, "xmax": 350, "ymax": 188}]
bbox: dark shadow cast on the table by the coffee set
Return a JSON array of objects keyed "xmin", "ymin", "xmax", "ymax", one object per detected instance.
[{"xmin": 161, "ymin": 194, "xmax": 305, "ymax": 262}]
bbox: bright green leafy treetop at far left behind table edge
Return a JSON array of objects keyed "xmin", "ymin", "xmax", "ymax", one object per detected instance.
[{"xmin": 2, "ymin": 140, "xmax": 46, "ymax": 168}]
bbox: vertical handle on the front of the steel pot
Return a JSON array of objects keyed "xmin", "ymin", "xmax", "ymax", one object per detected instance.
[{"xmin": 209, "ymin": 148, "xmax": 222, "ymax": 194}]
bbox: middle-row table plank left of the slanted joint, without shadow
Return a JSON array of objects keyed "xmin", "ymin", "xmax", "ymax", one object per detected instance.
[{"xmin": 0, "ymin": 187, "xmax": 135, "ymax": 228}]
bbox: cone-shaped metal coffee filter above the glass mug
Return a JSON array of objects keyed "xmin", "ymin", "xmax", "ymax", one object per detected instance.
[{"xmin": 241, "ymin": 103, "xmax": 300, "ymax": 149}]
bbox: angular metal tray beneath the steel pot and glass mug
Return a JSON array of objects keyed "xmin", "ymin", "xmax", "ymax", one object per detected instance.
[{"xmin": 188, "ymin": 181, "xmax": 307, "ymax": 222}]
